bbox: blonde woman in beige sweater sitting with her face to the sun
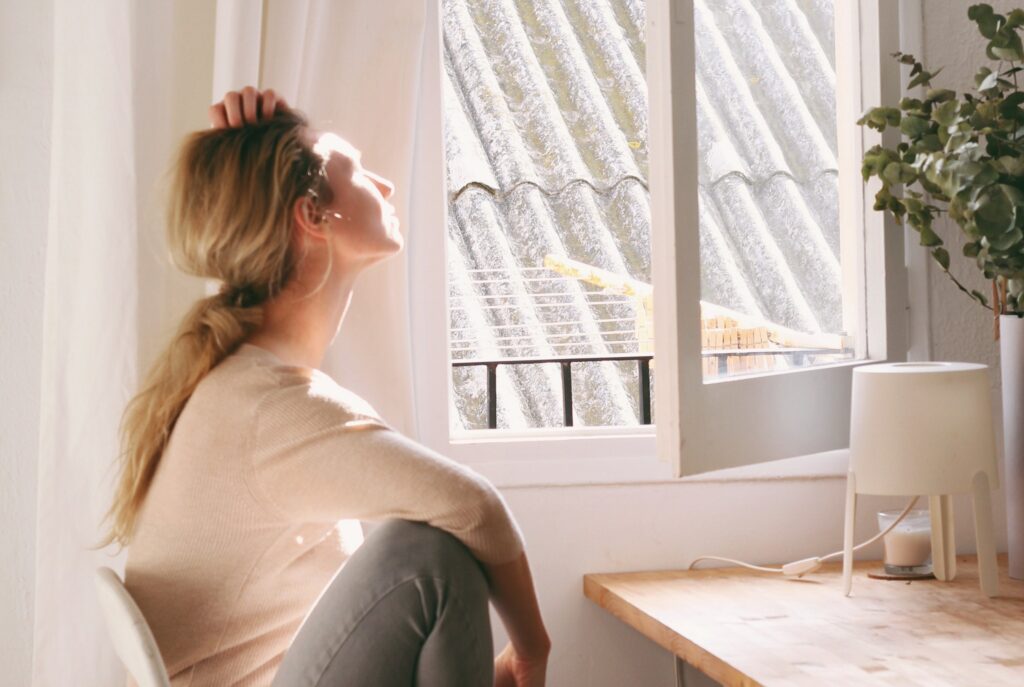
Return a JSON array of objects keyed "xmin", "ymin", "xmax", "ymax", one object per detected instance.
[{"xmin": 101, "ymin": 88, "xmax": 550, "ymax": 687}]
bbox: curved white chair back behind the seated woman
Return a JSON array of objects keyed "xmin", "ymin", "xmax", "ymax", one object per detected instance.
[{"xmin": 96, "ymin": 567, "xmax": 170, "ymax": 687}]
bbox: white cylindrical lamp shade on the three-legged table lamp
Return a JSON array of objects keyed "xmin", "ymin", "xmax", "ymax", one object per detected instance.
[{"xmin": 850, "ymin": 362, "xmax": 998, "ymax": 496}]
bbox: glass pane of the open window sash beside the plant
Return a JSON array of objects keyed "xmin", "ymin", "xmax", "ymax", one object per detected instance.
[{"xmin": 694, "ymin": 0, "xmax": 859, "ymax": 379}]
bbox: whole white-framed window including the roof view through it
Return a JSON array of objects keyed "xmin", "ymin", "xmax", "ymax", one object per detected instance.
[{"xmin": 411, "ymin": 0, "xmax": 905, "ymax": 483}]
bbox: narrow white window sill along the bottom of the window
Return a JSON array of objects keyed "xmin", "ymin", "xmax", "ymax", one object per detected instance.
[{"xmin": 469, "ymin": 448, "xmax": 849, "ymax": 489}]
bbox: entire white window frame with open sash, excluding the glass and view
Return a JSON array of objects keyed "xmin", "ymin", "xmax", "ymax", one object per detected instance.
[{"xmin": 408, "ymin": 0, "xmax": 906, "ymax": 486}]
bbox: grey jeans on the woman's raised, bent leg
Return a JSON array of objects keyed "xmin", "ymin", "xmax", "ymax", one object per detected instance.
[{"xmin": 272, "ymin": 520, "xmax": 495, "ymax": 687}]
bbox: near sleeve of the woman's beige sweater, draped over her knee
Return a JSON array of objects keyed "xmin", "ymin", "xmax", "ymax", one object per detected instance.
[{"xmin": 243, "ymin": 368, "xmax": 523, "ymax": 563}]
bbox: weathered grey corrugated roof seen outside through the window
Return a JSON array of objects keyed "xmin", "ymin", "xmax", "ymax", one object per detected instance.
[{"xmin": 442, "ymin": 0, "xmax": 841, "ymax": 428}]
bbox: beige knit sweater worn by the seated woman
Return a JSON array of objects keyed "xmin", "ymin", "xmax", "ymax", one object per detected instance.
[{"xmin": 125, "ymin": 344, "xmax": 523, "ymax": 687}]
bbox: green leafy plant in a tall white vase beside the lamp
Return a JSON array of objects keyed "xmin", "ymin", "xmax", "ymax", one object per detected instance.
[{"xmin": 857, "ymin": 4, "xmax": 1024, "ymax": 579}]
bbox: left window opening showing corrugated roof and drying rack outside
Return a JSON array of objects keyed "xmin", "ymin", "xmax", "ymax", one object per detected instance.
[{"xmin": 441, "ymin": 0, "xmax": 653, "ymax": 431}]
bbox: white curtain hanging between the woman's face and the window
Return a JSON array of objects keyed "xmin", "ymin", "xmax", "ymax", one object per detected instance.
[{"xmin": 260, "ymin": 0, "xmax": 432, "ymax": 437}]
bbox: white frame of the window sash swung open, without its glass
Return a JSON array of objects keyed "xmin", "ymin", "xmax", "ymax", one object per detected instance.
[{"xmin": 647, "ymin": 0, "xmax": 907, "ymax": 477}]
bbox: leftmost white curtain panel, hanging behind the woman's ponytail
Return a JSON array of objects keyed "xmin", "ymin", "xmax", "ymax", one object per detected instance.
[{"xmin": 33, "ymin": 1, "xmax": 137, "ymax": 687}]
